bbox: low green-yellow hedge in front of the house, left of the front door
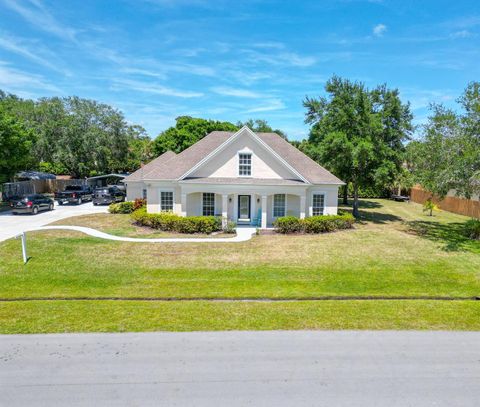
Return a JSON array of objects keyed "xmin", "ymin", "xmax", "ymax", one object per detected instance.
[{"xmin": 131, "ymin": 207, "xmax": 222, "ymax": 234}]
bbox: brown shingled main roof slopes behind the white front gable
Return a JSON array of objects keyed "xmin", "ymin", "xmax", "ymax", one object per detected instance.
[{"xmin": 137, "ymin": 128, "xmax": 343, "ymax": 184}]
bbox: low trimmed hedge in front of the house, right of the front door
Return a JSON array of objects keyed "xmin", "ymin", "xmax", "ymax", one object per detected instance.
[{"xmin": 273, "ymin": 213, "xmax": 355, "ymax": 234}]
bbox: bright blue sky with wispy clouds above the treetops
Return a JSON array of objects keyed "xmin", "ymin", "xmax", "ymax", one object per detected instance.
[{"xmin": 0, "ymin": 0, "xmax": 480, "ymax": 139}]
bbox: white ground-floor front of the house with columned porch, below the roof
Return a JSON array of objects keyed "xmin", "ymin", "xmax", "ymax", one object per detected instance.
[{"xmin": 145, "ymin": 179, "xmax": 338, "ymax": 229}]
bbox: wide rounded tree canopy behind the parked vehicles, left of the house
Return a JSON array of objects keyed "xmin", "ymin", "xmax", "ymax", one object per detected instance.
[{"xmin": 0, "ymin": 92, "xmax": 151, "ymax": 179}]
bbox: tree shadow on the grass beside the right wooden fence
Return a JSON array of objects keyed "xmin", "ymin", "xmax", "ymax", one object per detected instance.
[{"xmin": 405, "ymin": 220, "xmax": 480, "ymax": 253}]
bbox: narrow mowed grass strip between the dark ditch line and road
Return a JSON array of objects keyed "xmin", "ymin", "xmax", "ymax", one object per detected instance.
[{"xmin": 0, "ymin": 300, "xmax": 480, "ymax": 334}]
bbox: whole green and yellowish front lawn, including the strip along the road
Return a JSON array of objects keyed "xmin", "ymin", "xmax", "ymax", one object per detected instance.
[{"xmin": 0, "ymin": 200, "xmax": 480, "ymax": 333}]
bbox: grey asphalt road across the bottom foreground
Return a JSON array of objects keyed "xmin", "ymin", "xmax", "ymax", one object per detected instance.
[{"xmin": 0, "ymin": 331, "xmax": 480, "ymax": 407}]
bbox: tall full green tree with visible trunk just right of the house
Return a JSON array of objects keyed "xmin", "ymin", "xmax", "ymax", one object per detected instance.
[{"xmin": 301, "ymin": 76, "xmax": 413, "ymax": 216}]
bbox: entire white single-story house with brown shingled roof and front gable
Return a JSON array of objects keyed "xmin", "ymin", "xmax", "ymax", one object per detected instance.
[{"xmin": 124, "ymin": 127, "xmax": 344, "ymax": 228}]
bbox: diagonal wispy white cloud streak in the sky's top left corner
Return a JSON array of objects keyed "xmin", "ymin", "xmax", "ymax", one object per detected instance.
[{"xmin": 4, "ymin": 0, "xmax": 76, "ymax": 42}]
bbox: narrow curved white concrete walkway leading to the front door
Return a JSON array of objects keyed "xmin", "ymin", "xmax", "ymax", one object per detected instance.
[{"xmin": 24, "ymin": 225, "xmax": 256, "ymax": 243}]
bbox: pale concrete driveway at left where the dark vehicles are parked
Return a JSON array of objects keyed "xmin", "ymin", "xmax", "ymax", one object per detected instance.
[{"xmin": 0, "ymin": 202, "xmax": 108, "ymax": 242}]
